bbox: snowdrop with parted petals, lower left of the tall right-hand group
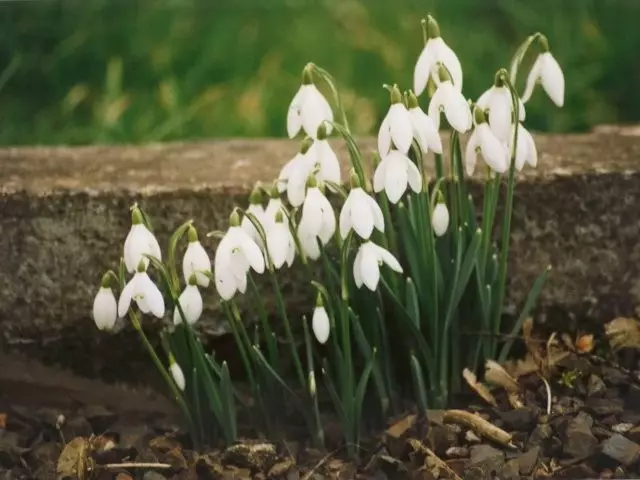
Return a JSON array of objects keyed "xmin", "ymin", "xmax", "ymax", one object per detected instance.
[{"xmin": 465, "ymin": 108, "xmax": 509, "ymax": 176}]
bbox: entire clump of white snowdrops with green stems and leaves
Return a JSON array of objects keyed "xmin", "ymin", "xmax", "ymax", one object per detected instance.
[{"xmin": 94, "ymin": 16, "xmax": 564, "ymax": 455}]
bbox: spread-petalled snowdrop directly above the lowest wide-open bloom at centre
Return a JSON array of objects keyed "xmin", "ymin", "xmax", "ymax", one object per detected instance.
[{"xmin": 340, "ymin": 187, "xmax": 384, "ymax": 240}]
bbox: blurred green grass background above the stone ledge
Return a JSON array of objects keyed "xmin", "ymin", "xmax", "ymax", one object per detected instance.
[{"xmin": 0, "ymin": 0, "xmax": 640, "ymax": 145}]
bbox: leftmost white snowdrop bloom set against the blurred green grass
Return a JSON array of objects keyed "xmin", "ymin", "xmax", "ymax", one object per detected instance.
[{"xmin": 287, "ymin": 64, "xmax": 333, "ymax": 138}]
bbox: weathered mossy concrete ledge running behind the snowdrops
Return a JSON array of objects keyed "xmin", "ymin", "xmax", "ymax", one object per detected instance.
[{"xmin": 0, "ymin": 127, "xmax": 640, "ymax": 380}]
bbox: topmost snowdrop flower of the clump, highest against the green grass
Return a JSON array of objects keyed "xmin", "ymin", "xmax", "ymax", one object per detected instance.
[{"xmin": 413, "ymin": 15, "xmax": 462, "ymax": 95}]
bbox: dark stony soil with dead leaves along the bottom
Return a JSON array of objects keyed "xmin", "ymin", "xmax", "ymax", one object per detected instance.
[{"xmin": 0, "ymin": 344, "xmax": 640, "ymax": 480}]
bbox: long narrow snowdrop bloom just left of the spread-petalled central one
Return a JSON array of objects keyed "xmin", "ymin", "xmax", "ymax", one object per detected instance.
[{"xmin": 298, "ymin": 187, "xmax": 336, "ymax": 260}]
